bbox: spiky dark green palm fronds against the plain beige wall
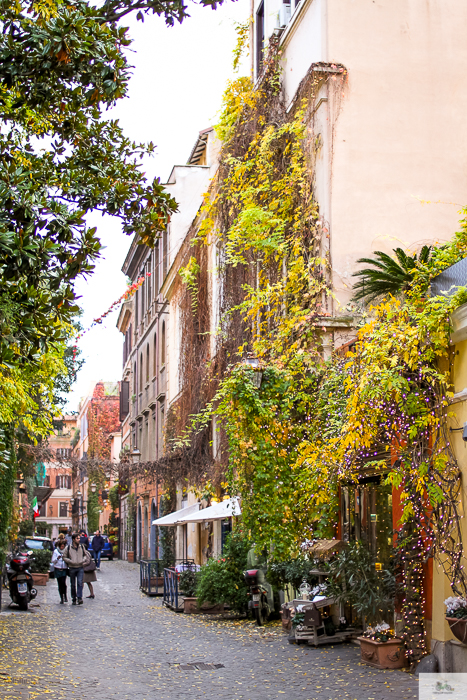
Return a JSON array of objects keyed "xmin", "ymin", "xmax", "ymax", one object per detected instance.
[{"xmin": 353, "ymin": 245, "xmax": 432, "ymax": 303}]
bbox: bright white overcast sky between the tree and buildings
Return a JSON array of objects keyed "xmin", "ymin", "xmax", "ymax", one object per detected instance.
[{"xmin": 66, "ymin": 0, "xmax": 250, "ymax": 411}]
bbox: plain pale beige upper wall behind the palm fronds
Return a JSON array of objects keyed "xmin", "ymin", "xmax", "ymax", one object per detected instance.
[{"xmin": 327, "ymin": 0, "xmax": 467, "ymax": 302}]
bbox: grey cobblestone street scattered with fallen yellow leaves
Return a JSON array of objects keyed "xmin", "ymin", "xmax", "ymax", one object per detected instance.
[{"xmin": 0, "ymin": 561, "xmax": 418, "ymax": 700}]
